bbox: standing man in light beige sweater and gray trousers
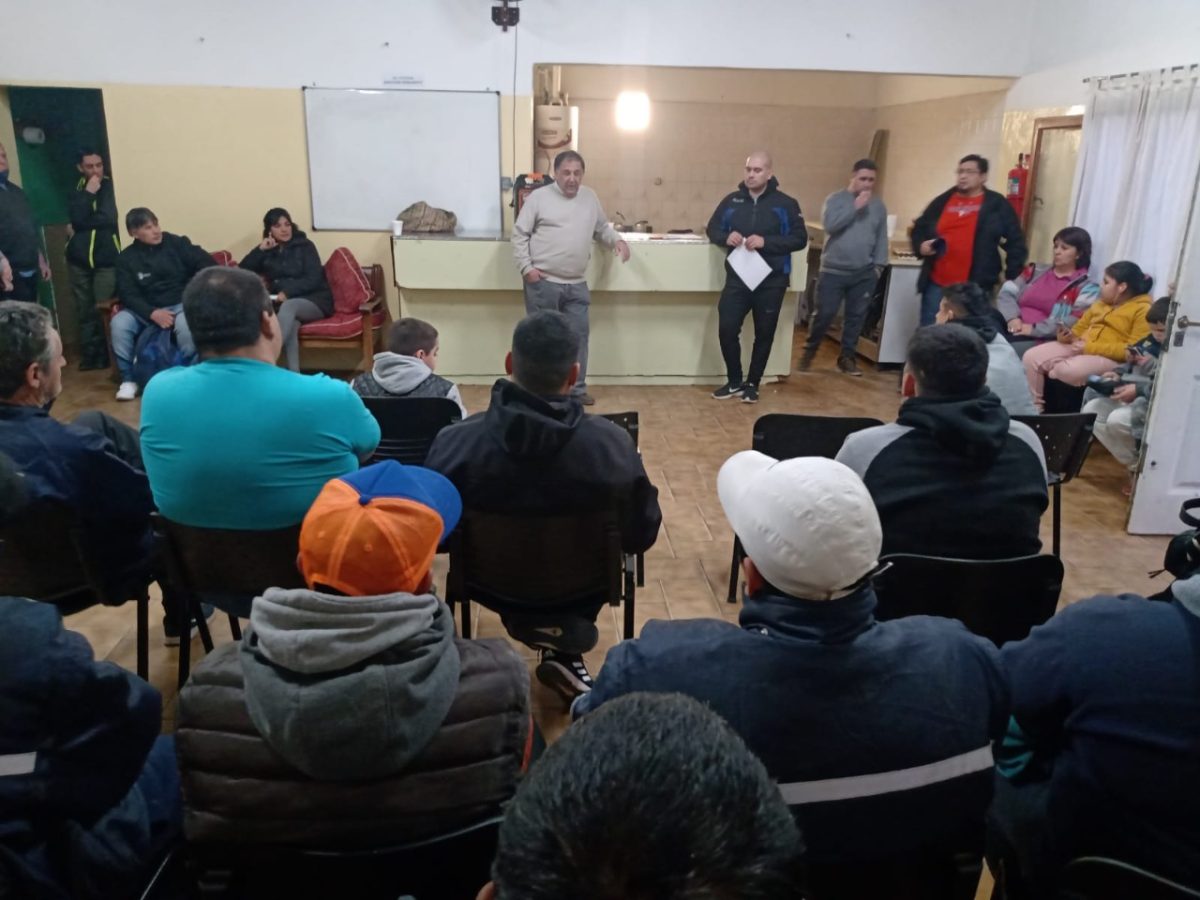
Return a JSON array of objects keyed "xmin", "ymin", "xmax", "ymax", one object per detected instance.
[{"xmin": 512, "ymin": 150, "xmax": 629, "ymax": 406}]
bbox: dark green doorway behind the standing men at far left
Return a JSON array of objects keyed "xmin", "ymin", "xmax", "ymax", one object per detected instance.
[{"xmin": 0, "ymin": 86, "xmax": 113, "ymax": 350}]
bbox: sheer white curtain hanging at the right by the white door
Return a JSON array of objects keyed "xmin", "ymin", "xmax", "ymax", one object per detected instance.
[{"xmin": 1072, "ymin": 68, "xmax": 1200, "ymax": 296}]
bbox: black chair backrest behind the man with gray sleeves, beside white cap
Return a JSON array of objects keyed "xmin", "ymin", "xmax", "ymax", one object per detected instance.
[{"xmin": 875, "ymin": 553, "xmax": 1063, "ymax": 647}]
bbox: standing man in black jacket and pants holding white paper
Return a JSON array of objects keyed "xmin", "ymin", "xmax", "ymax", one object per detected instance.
[{"xmin": 707, "ymin": 150, "xmax": 809, "ymax": 403}]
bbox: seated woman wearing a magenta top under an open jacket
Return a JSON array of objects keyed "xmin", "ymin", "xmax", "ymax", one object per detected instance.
[{"xmin": 996, "ymin": 226, "xmax": 1099, "ymax": 356}]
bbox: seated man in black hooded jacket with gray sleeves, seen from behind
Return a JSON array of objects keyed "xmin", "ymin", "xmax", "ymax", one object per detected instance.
[{"xmin": 838, "ymin": 324, "xmax": 1048, "ymax": 559}]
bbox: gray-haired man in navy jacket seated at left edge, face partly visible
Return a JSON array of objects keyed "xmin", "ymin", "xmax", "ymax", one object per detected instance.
[{"xmin": 0, "ymin": 301, "xmax": 192, "ymax": 644}]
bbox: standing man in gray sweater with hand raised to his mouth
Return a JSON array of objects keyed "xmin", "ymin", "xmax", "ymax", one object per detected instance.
[{"xmin": 796, "ymin": 160, "xmax": 888, "ymax": 376}]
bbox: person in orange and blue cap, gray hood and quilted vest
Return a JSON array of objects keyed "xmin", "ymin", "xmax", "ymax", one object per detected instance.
[{"xmin": 179, "ymin": 460, "xmax": 532, "ymax": 846}]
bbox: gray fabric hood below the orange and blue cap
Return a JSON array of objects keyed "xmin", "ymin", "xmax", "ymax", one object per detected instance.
[{"xmin": 240, "ymin": 588, "xmax": 460, "ymax": 781}]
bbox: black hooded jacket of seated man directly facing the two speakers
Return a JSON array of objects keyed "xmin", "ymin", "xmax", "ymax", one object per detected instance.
[{"xmin": 425, "ymin": 378, "xmax": 662, "ymax": 553}]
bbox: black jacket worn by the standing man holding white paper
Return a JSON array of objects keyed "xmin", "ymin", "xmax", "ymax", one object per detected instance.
[{"xmin": 704, "ymin": 176, "xmax": 809, "ymax": 282}]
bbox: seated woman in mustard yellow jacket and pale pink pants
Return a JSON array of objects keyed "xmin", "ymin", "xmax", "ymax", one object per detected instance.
[{"xmin": 1021, "ymin": 260, "xmax": 1154, "ymax": 412}]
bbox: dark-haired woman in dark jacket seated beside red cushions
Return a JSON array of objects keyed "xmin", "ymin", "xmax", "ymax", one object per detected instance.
[{"xmin": 239, "ymin": 206, "xmax": 334, "ymax": 372}]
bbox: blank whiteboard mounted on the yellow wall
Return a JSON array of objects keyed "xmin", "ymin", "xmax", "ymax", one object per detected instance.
[{"xmin": 304, "ymin": 88, "xmax": 503, "ymax": 233}]
